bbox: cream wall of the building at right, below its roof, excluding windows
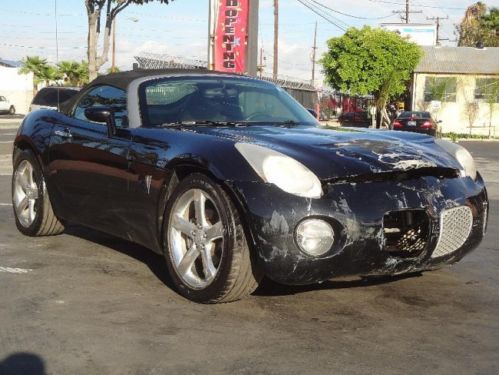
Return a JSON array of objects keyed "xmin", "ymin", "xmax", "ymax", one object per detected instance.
[{"xmin": 412, "ymin": 74, "xmax": 499, "ymax": 136}]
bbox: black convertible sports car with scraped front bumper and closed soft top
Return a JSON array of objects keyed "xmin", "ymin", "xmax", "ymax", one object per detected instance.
[{"xmin": 12, "ymin": 70, "xmax": 488, "ymax": 303}]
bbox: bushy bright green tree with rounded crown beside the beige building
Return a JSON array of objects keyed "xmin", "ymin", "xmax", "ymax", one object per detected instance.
[{"xmin": 321, "ymin": 26, "xmax": 422, "ymax": 129}]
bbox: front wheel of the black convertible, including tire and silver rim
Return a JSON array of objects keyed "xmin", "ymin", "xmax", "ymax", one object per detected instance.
[{"xmin": 164, "ymin": 173, "xmax": 262, "ymax": 303}]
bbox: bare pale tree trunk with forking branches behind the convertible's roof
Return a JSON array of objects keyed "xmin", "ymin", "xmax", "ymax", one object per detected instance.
[{"xmin": 85, "ymin": 0, "xmax": 173, "ymax": 80}]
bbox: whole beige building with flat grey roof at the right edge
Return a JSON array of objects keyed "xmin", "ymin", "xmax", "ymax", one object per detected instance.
[{"xmin": 412, "ymin": 47, "xmax": 499, "ymax": 136}]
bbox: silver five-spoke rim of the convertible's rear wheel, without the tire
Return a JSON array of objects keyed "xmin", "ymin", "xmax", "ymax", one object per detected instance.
[{"xmin": 12, "ymin": 160, "xmax": 39, "ymax": 228}]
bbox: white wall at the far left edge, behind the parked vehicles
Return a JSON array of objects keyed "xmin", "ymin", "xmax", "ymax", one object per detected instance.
[{"xmin": 0, "ymin": 66, "xmax": 33, "ymax": 114}]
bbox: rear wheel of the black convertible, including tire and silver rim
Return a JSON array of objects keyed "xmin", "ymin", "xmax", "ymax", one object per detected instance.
[{"xmin": 12, "ymin": 150, "xmax": 64, "ymax": 237}]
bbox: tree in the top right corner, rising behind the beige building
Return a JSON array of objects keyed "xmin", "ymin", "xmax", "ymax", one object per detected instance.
[{"xmin": 457, "ymin": 1, "xmax": 499, "ymax": 47}]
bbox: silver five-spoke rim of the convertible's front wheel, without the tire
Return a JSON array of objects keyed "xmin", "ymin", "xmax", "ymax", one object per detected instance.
[{"xmin": 168, "ymin": 189, "xmax": 224, "ymax": 289}]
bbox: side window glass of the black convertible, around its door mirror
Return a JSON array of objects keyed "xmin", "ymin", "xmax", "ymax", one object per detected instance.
[{"xmin": 73, "ymin": 86, "xmax": 128, "ymax": 128}]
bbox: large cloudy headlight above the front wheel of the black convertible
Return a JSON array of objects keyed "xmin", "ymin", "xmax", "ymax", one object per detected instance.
[{"xmin": 235, "ymin": 143, "xmax": 322, "ymax": 198}]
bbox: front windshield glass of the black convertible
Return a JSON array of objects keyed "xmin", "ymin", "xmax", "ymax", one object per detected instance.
[{"xmin": 139, "ymin": 77, "xmax": 317, "ymax": 126}]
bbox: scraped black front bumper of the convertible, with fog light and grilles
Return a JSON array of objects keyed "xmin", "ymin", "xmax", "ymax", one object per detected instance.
[{"xmin": 232, "ymin": 166, "xmax": 488, "ymax": 284}]
